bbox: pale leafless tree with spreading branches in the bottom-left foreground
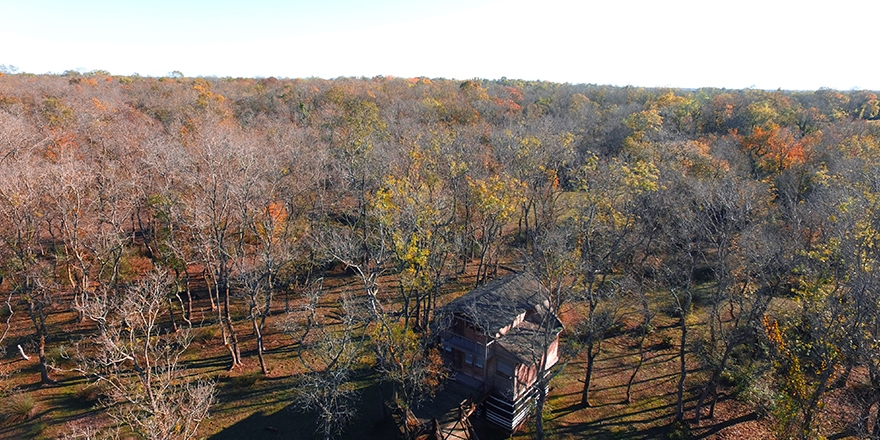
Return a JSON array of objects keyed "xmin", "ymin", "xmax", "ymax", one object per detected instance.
[{"xmin": 77, "ymin": 272, "xmax": 214, "ymax": 439}]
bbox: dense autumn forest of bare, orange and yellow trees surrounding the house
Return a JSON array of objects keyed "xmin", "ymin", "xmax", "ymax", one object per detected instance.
[{"xmin": 0, "ymin": 71, "xmax": 880, "ymax": 439}]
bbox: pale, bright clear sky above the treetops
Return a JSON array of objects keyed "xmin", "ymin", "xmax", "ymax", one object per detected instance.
[{"xmin": 0, "ymin": 0, "xmax": 880, "ymax": 90}]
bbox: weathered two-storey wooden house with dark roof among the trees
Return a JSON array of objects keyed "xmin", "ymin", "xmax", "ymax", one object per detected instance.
[{"xmin": 438, "ymin": 273, "xmax": 562, "ymax": 431}]
